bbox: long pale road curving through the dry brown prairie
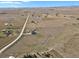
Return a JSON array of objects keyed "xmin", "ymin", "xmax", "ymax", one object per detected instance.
[{"xmin": 0, "ymin": 15, "xmax": 30, "ymax": 54}]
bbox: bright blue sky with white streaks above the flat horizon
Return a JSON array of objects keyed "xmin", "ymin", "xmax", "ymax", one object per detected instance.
[{"xmin": 0, "ymin": 0, "xmax": 79, "ymax": 8}]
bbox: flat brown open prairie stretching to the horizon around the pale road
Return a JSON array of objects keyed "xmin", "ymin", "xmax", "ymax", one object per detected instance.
[{"xmin": 0, "ymin": 7, "xmax": 79, "ymax": 58}]
